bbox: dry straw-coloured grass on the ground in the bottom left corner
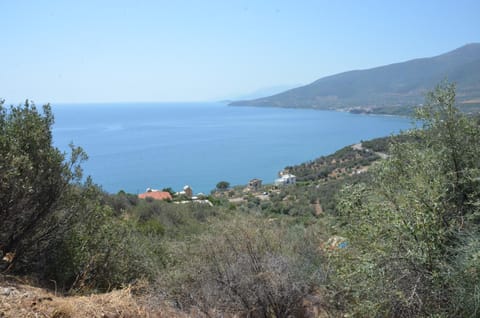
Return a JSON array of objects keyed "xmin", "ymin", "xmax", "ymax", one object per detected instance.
[{"xmin": 0, "ymin": 277, "xmax": 190, "ymax": 318}]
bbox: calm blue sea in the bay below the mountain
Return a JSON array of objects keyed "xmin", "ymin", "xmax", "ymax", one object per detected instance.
[{"xmin": 53, "ymin": 103, "xmax": 411, "ymax": 193}]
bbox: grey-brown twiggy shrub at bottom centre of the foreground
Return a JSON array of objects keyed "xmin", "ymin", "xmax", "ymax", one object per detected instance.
[{"xmin": 160, "ymin": 216, "xmax": 326, "ymax": 317}]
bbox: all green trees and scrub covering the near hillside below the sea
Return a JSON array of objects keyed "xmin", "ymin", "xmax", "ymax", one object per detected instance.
[{"xmin": 0, "ymin": 84, "xmax": 480, "ymax": 317}]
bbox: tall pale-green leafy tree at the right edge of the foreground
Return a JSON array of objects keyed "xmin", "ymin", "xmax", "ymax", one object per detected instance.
[{"xmin": 339, "ymin": 84, "xmax": 480, "ymax": 317}]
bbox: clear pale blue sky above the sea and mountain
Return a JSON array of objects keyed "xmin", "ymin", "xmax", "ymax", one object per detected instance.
[{"xmin": 0, "ymin": 0, "xmax": 480, "ymax": 103}]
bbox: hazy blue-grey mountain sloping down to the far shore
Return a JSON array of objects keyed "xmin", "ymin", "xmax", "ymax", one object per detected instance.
[{"xmin": 230, "ymin": 43, "xmax": 480, "ymax": 112}]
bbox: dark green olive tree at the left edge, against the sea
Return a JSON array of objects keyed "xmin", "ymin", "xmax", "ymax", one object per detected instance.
[{"xmin": 0, "ymin": 100, "xmax": 86, "ymax": 269}]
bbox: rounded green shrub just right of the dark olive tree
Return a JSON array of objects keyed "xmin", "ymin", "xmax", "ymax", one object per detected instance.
[{"xmin": 49, "ymin": 196, "xmax": 165, "ymax": 292}]
